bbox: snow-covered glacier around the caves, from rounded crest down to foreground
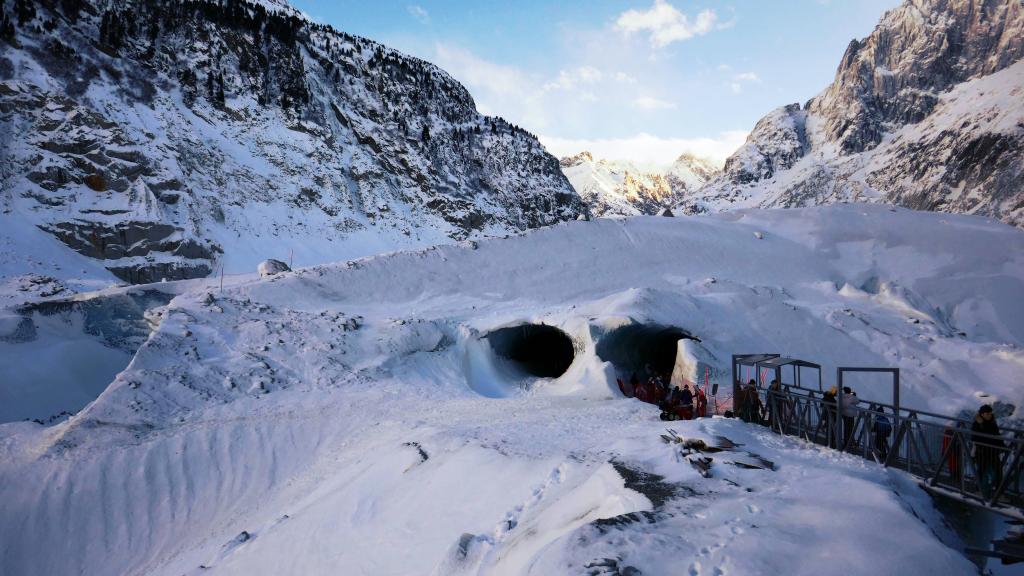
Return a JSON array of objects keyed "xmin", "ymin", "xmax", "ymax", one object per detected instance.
[{"xmin": 0, "ymin": 205, "xmax": 1024, "ymax": 575}]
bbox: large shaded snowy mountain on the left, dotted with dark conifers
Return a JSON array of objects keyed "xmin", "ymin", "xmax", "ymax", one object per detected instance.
[{"xmin": 0, "ymin": 0, "xmax": 585, "ymax": 283}]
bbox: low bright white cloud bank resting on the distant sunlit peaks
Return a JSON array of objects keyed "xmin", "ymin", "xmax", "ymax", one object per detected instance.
[{"xmin": 539, "ymin": 130, "xmax": 748, "ymax": 166}]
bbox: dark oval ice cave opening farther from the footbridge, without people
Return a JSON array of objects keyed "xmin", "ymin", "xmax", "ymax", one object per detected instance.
[{"xmin": 486, "ymin": 324, "xmax": 575, "ymax": 378}]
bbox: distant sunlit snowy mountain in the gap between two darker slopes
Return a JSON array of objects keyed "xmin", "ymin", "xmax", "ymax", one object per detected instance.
[{"xmin": 560, "ymin": 152, "xmax": 717, "ymax": 216}]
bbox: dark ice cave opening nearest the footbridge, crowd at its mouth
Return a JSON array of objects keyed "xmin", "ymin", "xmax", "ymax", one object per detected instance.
[{"xmin": 596, "ymin": 323, "xmax": 700, "ymax": 380}]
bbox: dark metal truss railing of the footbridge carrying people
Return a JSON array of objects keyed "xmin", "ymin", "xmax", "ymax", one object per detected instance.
[{"xmin": 759, "ymin": 386, "xmax": 1024, "ymax": 518}]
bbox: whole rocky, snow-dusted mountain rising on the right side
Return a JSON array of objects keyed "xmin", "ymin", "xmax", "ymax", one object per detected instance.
[{"xmin": 681, "ymin": 0, "xmax": 1024, "ymax": 227}]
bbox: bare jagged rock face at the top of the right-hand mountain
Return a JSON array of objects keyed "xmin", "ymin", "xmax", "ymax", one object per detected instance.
[{"xmin": 808, "ymin": 0, "xmax": 1024, "ymax": 154}]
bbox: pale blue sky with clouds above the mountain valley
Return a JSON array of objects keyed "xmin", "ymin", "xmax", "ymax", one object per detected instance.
[{"xmin": 292, "ymin": 0, "xmax": 899, "ymax": 163}]
